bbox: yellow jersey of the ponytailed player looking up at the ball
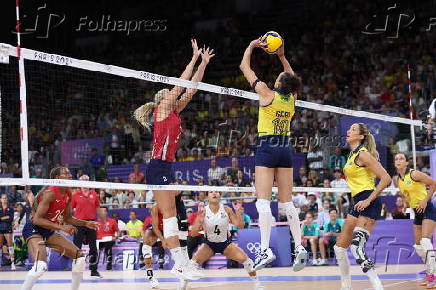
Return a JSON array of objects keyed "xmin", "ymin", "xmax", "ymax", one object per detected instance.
[{"xmin": 344, "ymin": 145, "xmax": 375, "ymax": 196}]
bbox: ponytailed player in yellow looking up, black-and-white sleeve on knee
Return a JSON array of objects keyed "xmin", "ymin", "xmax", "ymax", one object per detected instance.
[{"xmin": 334, "ymin": 123, "xmax": 391, "ymax": 290}]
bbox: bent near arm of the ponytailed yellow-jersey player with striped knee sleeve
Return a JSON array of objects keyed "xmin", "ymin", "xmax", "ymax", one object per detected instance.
[{"xmin": 354, "ymin": 151, "xmax": 392, "ymax": 211}]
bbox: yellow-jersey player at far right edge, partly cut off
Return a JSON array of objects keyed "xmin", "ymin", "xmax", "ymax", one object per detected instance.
[{"xmin": 395, "ymin": 153, "xmax": 436, "ymax": 289}]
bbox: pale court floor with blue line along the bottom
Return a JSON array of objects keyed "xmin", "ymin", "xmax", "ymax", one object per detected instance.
[{"xmin": 0, "ymin": 265, "xmax": 425, "ymax": 290}]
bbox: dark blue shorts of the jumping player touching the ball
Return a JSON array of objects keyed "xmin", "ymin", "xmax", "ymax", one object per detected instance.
[{"xmin": 255, "ymin": 135, "xmax": 293, "ymax": 168}]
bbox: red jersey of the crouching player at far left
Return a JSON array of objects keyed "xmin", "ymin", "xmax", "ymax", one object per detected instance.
[{"xmin": 36, "ymin": 186, "xmax": 71, "ymax": 224}]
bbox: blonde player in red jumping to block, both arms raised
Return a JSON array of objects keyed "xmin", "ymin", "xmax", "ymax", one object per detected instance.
[{"xmin": 133, "ymin": 40, "xmax": 214, "ymax": 280}]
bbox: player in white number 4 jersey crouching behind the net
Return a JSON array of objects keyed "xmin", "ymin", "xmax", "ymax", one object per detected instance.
[{"xmin": 182, "ymin": 191, "xmax": 263, "ymax": 290}]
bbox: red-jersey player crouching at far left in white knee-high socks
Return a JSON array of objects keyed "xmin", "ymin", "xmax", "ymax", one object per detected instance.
[{"xmin": 21, "ymin": 167, "xmax": 98, "ymax": 290}]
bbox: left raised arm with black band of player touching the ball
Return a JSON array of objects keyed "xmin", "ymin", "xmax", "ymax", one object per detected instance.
[{"xmin": 239, "ymin": 39, "xmax": 274, "ymax": 106}]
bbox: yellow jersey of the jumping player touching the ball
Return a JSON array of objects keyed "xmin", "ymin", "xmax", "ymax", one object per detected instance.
[{"xmin": 257, "ymin": 91, "xmax": 295, "ymax": 136}]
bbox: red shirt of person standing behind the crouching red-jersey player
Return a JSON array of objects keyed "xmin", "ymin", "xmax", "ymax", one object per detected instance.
[{"xmin": 71, "ymin": 189, "xmax": 100, "ymax": 220}]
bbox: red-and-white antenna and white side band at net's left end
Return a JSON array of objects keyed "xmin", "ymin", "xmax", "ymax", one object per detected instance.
[{"xmin": 15, "ymin": 0, "xmax": 30, "ymax": 181}]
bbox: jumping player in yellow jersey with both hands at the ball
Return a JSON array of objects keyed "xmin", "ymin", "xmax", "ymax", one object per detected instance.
[{"xmin": 240, "ymin": 40, "xmax": 307, "ymax": 271}]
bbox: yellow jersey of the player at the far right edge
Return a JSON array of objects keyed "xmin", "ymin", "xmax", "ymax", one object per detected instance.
[{"xmin": 398, "ymin": 168, "xmax": 427, "ymax": 208}]
